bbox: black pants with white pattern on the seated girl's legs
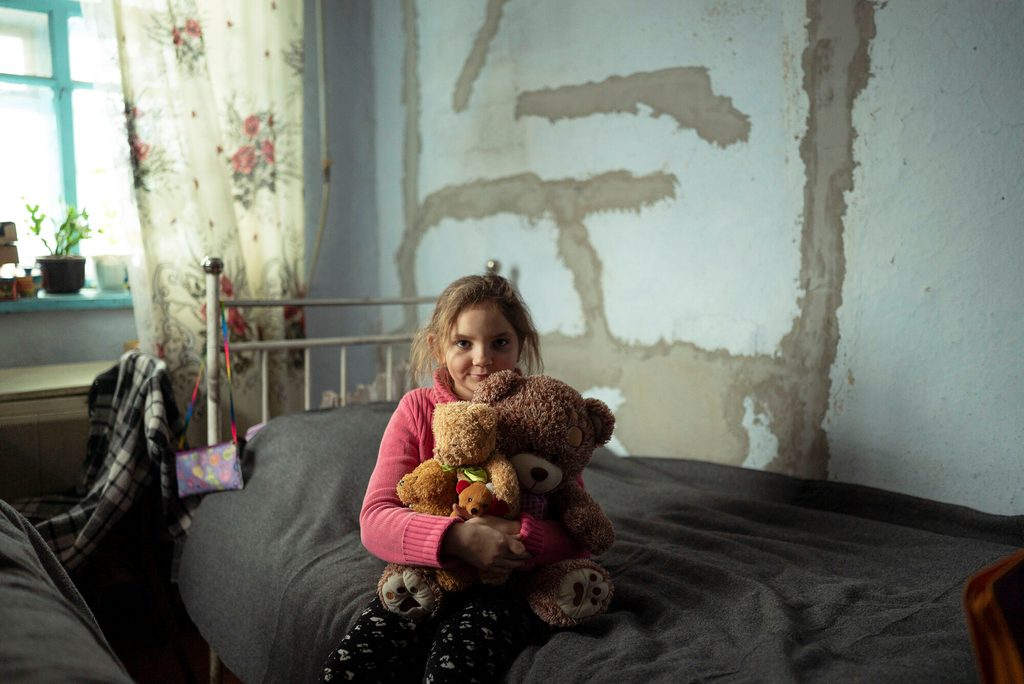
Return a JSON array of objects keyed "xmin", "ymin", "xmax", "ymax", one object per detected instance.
[{"xmin": 321, "ymin": 586, "xmax": 549, "ymax": 684}]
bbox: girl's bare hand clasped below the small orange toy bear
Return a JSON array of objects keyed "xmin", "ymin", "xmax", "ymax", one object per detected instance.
[{"xmin": 441, "ymin": 515, "xmax": 529, "ymax": 574}]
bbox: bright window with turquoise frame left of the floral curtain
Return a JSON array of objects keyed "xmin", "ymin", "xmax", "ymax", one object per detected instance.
[{"xmin": 0, "ymin": 0, "xmax": 136, "ymax": 268}]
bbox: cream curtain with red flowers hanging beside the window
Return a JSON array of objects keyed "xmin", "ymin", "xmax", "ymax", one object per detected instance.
[{"xmin": 113, "ymin": 0, "xmax": 304, "ymax": 441}]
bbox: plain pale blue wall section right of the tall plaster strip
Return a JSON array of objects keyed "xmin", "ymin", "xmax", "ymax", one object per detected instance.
[{"xmin": 825, "ymin": 2, "xmax": 1024, "ymax": 514}]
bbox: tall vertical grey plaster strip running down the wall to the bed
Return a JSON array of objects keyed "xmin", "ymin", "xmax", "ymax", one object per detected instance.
[{"xmin": 765, "ymin": 0, "xmax": 876, "ymax": 477}]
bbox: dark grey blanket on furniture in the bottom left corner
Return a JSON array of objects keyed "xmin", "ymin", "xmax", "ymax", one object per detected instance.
[{"xmin": 0, "ymin": 501, "xmax": 131, "ymax": 684}]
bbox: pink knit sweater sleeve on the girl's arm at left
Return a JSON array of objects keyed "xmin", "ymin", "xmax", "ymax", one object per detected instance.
[{"xmin": 359, "ymin": 389, "xmax": 455, "ymax": 567}]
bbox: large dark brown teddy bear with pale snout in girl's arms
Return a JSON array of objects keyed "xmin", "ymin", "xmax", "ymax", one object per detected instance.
[{"xmin": 473, "ymin": 371, "xmax": 615, "ymax": 627}]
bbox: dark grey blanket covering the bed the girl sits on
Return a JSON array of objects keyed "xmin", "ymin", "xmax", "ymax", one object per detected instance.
[{"xmin": 179, "ymin": 403, "xmax": 1024, "ymax": 684}]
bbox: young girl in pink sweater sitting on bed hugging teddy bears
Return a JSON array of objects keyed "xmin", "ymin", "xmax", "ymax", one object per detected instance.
[{"xmin": 321, "ymin": 274, "xmax": 584, "ymax": 682}]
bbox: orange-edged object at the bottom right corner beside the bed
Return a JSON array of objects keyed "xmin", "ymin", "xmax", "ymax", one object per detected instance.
[{"xmin": 964, "ymin": 550, "xmax": 1024, "ymax": 684}]
